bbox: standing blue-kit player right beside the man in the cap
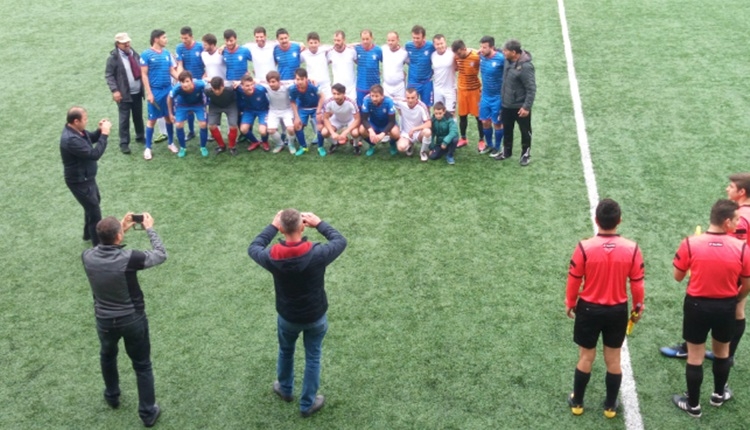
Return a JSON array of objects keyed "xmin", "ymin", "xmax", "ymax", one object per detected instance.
[{"xmin": 141, "ymin": 30, "xmax": 178, "ymax": 160}]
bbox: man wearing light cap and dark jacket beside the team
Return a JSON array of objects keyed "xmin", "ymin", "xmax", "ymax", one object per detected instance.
[{"xmin": 104, "ymin": 33, "xmax": 145, "ymax": 154}]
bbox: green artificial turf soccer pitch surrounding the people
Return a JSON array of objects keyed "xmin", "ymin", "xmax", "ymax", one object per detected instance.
[{"xmin": 0, "ymin": 0, "xmax": 750, "ymax": 429}]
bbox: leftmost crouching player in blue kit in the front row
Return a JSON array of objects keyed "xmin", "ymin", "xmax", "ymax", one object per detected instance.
[{"xmin": 167, "ymin": 70, "xmax": 208, "ymax": 158}]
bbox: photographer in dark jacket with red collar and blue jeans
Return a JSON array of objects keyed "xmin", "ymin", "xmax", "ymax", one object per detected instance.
[{"xmin": 247, "ymin": 209, "xmax": 346, "ymax": 417}]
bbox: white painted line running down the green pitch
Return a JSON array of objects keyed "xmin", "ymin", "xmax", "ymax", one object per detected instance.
[{"xmin": 557, "ymin": 0, "xmax": 643, "ymax": 430}]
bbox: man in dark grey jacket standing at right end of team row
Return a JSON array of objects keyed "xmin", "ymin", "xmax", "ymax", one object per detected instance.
[{"xmin": 495, "ymin": 39, "xmax": 536, "ymax": 166}]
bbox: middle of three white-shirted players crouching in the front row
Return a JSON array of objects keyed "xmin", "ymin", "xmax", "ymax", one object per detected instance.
[{"xmin": 321, "ymin": 84, "xmax": 360, "ymax": 153}]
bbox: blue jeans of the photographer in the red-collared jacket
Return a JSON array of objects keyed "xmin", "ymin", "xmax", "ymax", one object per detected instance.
[{"xmin": 276, "ymin": 315, "xmax": 328, "ymax": 412}]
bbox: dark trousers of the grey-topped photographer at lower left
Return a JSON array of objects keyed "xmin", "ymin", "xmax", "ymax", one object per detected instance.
[{"xmin": 96, "ymin": 313, "xmax": 156, "ymax": 421}]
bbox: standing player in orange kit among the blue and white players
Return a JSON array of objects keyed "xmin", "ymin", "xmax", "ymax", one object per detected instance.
[{"xmin": 451, "ymin": 39, "xmax": 486, "ymax": 152}]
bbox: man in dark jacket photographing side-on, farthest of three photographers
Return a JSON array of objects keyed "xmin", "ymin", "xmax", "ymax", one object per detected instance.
[{"xmin": 60, "ymin": 106, "xmax": 112, "ymax": 246}]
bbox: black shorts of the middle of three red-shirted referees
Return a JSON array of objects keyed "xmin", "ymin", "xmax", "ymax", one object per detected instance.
[{"xmin": 682, "ymin": 296, "xmax": 737, "ymax": 344}]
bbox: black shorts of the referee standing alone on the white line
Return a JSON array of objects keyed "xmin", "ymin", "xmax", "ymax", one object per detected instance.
[{"xmin": 573, "ymin": 300, "xmax": 629, "ymax": 349}]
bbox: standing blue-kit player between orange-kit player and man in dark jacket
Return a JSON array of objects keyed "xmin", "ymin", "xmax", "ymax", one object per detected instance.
[{"xmin": 479, "ymin": 36, "xmax": 505, "ymax": 158}]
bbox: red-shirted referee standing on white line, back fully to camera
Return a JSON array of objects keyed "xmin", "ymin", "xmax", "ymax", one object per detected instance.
[{"xmin": 565, "ymin": 199, "xmax": 644, "ymax": 418}]
